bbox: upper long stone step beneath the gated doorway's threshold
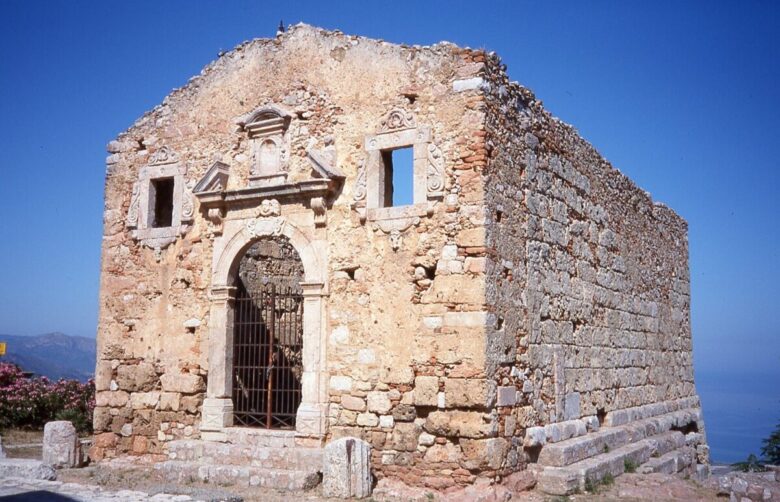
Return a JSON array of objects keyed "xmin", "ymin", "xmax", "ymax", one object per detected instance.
[{"xmin": 168, "ymin": 439, "xmax": 322, "ymax": 470}]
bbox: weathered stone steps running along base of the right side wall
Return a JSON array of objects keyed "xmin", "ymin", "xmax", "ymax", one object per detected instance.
[{"xmin": 530, "ymin": 409, "xmax": 704, "ymax": 495}]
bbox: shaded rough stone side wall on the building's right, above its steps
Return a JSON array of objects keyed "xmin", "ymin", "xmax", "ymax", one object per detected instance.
[{"xmin": 481, "ymin": 56, "xmax": 695, "ymax": 470}]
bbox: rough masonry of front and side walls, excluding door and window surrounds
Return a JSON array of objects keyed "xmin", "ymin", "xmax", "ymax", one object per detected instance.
[{"xmin": 92, "ymin": 25, "xmax": 695, "ymax": 489}]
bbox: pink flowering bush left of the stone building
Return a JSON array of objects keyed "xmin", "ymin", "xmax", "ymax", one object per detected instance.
[{"xmin": 0, "ymin": 363, "xmax": 95, "ymax": 432}]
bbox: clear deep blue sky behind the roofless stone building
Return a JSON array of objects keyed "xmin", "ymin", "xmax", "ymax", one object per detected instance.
[{"xmin": 0, "ymin": 0, "xmax": 780, "ymax": 460}]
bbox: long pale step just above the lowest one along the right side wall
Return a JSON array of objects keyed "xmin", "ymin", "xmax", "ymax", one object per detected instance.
[{"xmin": 537, "ymin": 410, "xmax": 697, "ymax": 467}]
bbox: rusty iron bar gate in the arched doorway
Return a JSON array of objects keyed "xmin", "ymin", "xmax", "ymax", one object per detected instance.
[{"xmin": 233, "ymin": 281, "xmax": 303, "ymax": 429}]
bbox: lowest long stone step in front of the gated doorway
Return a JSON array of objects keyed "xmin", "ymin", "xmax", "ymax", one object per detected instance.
[{"xmin": 154, "ymin": 460, "xmax": 320, "ymax": 491}]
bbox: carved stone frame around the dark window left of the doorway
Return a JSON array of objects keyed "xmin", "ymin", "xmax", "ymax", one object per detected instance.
[{"xmin": 126, "ymin": 148, "xmax": 195, "ymax": 249}]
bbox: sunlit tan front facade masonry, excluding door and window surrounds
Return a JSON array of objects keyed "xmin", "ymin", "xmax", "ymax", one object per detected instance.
[{"xmin": 92, "ymin": 26, "xmax": 497, "ymax": 487}]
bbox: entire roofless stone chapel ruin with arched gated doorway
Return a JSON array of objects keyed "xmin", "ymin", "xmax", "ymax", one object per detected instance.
[{"xmin": 91, "ymin": 25, "xmax": 709, "ymax": 494}]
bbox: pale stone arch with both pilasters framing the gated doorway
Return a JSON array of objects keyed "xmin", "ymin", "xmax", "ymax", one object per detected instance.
[{"xmin": 201, "ymin": 216, "xmax": 328, "ymax": 437}]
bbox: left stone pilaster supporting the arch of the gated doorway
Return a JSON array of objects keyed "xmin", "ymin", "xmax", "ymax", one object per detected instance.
[{"xmin": 200, "ymin": 286, "xmax": 236, "ymax": 431}]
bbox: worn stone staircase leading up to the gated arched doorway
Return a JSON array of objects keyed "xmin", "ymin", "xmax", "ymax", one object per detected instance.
[{"xmin": 154, "ymin": 428, "xmax": 322, "ymax": 491}]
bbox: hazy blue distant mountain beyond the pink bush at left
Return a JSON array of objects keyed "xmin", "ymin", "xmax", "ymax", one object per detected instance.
[{"xmin": 0, "ymin": 333, "xmax": 96, "ymax": 381}]
